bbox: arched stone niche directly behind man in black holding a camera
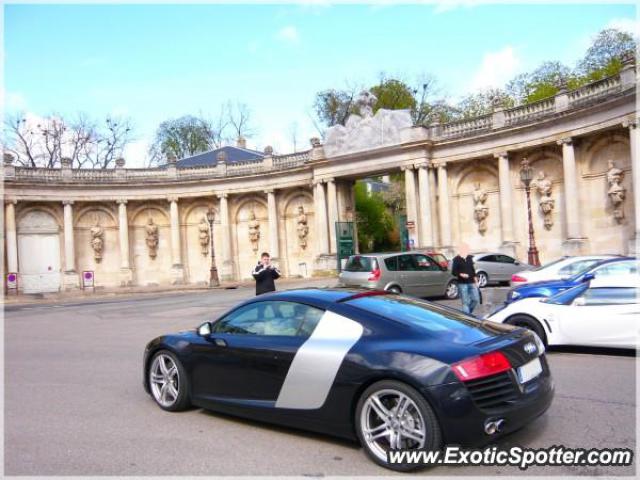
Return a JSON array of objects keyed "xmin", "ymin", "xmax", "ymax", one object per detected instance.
[{"xmin": 232, "ymin": 197, "xmax": 269, "ymax": 279}]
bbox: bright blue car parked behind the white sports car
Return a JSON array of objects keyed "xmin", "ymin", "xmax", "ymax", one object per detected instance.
[{"xmin": 505, "ymin": 257, "xmax": 638, "ymax": 304}]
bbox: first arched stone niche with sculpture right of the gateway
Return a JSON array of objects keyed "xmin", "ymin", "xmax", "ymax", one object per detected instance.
[{"xmin": 452, "ymin": 166, "xmax": 501, "ymax": 251}]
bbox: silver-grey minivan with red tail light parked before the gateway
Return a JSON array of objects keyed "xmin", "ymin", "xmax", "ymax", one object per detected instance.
[{"xmin": 338, "ymin": 252, "xmax": 458, "ymax": 299}]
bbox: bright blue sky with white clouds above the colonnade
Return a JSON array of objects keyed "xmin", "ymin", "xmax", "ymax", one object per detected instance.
[{"xmin": 4, "ymin": 2, "xmax": 638, "ymax": 167}]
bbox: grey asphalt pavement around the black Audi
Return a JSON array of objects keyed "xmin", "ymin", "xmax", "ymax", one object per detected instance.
[{"xmin": 4, "ymin": 282, "xmax": 636, "ymax": 476}]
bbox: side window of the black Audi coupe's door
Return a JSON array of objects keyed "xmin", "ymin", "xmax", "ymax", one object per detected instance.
[{"xmin": 212, "ymin": 301, "xmax": 324, "ymax": 337}]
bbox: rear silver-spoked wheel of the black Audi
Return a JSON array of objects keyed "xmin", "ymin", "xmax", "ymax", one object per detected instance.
[{"xmin": 356, "ymin": 380, "xmax": 442, "ymax": 471}]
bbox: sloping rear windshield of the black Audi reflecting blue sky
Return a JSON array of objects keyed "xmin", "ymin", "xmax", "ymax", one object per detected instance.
[{"xmin": 349, "ymin": 295, "xmax": 493, "ymax": 344}]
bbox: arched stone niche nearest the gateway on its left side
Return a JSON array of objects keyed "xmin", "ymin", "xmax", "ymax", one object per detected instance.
[{"xmin": 280, "ymin": 192, "xmax": 317, "ymax": 277}]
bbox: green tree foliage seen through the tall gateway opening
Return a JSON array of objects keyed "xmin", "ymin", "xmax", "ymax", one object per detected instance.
[{"xmin": 354, "ymin": 181, "xmax": 393, "ymax": 253}]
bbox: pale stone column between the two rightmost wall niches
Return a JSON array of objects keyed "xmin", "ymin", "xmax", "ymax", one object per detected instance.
[{"xmin": 557, "ymin": 137, "xmax": 584, "ymax": 255}]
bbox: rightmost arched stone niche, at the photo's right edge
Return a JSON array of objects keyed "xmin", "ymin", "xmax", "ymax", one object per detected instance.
[{"xmin": 579, "ymin": 135, "xmax": 635, "ymax": 253}]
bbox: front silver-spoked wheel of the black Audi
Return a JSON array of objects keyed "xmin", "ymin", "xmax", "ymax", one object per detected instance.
[{"xmin": 148, "ymin": 350, "xmax": 191, "ymax": 412}]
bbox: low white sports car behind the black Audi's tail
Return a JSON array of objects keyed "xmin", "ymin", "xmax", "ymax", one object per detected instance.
[{"xmin": 485, "ymin": 274, "xmax": 640, "ymax": 348}]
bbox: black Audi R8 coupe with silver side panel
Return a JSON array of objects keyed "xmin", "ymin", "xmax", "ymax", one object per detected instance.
[{"xmin": 143, "ymin": 289, "xmax": 554, "ymax": 470}]
